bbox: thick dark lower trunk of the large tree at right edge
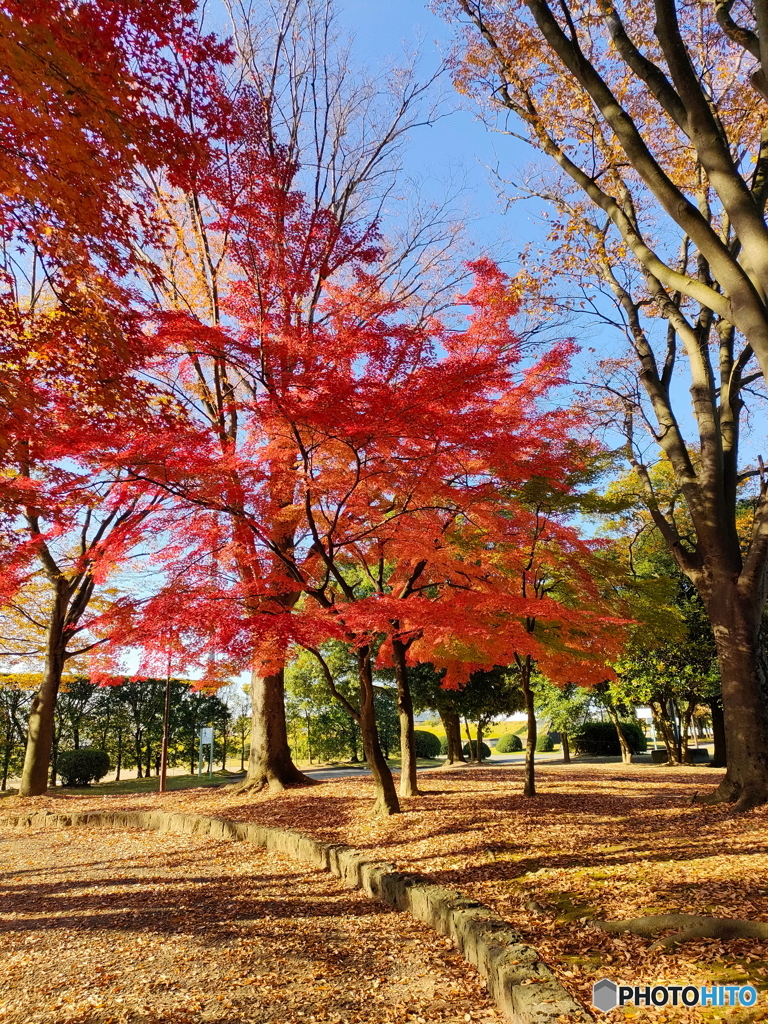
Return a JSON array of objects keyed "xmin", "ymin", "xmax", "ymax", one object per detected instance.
[{"xmin": 706, "ymin": 584, "xmax": 768, "ymax": 811}]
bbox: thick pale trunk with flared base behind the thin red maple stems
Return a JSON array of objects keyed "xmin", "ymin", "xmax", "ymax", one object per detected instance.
[{"xmin": 241, "ymin": 669, "xmax": 313, "ymax": 793}]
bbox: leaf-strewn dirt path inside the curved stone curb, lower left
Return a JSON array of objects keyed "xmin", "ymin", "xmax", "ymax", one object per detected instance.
[{"xmin": 0, "ymin": 828, "xmax": 502, "ymax": 1024}]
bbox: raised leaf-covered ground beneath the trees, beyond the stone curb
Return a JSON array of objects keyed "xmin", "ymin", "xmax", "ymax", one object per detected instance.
[{"xmin": 6, "ymin": 763, "xmax": 768, "ymax": 1024}]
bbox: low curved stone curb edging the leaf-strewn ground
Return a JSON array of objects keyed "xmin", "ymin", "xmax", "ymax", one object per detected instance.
[{"xmin": 0, "ymin": 811, "xmax": 594, "ymax": 1024}]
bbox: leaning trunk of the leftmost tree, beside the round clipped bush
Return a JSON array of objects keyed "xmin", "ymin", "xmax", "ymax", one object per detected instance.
[{"xmin": 18, "ymin": 618, "xmax": 66, "ymax": 797}]
